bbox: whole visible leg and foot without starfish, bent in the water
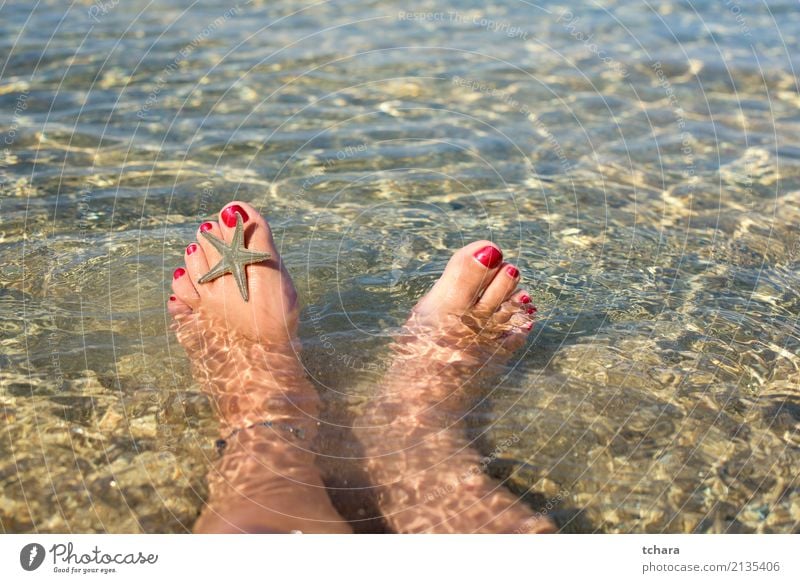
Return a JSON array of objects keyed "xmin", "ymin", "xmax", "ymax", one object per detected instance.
[{"xmin": 356, "ymin": 241, "xmax": 555, "ymax": 533}]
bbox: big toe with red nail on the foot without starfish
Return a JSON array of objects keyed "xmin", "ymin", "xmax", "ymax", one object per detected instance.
[{"xmin": 417, "ymin": 241, "xmax": 503, "ymax": 314}]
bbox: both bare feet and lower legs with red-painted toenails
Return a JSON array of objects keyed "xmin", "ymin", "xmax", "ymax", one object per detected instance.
[{"xmin": 168, "ymin": 201, "xmax": 553, "ymax": 532}]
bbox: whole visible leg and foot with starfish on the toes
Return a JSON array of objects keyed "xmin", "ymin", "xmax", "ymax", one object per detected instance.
[{"xmin": 168, "ymin": 202, "xmax": 350, "ymax": 532}]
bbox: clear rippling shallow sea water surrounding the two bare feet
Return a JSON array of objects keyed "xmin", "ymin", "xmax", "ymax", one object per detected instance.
[{"xmin": 0, "ymin": 0, "xmax": 800, "ymax": 532}]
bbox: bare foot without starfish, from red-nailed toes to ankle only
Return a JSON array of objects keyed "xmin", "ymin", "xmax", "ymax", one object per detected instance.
[{"xmin": 386, "ymin": 241, "xmax": 536, "ymax": 418}]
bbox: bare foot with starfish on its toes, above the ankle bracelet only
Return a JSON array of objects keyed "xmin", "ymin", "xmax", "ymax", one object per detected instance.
[{"xmin": 167, "ymin": 202, "xmax": 306, "ymax": 432}]
